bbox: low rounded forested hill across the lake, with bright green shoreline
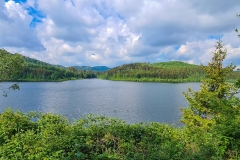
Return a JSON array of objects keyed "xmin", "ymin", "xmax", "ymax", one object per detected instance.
[{"xmin": 100, "ymin": 61, "xmax": 240, "ymax": 82}]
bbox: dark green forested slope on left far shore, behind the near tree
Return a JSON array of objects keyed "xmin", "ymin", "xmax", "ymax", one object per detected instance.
[{"xmin": 0, "ymin": 49, "xmax": 96, "ymax": 81}]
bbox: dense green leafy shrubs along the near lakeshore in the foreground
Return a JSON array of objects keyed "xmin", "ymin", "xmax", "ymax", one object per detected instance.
[{"xmin": 0, "ymin": 108, "xmax": 240, "ymax": 160}]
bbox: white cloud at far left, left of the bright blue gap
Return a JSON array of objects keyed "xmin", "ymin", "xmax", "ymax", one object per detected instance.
[{"xmin": 0, "ymin": 1, "xmax": 44, "ymax": 51}]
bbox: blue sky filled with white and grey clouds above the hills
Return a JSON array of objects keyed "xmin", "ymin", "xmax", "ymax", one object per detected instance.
[{"xmin": 0, "ymin": 0, "xmax": 240, "ymax": 67}]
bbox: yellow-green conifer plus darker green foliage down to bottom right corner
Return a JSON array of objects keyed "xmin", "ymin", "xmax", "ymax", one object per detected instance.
[{"xmin": 182, "ymin": 41, "xmax": 240, "ymax": 159}]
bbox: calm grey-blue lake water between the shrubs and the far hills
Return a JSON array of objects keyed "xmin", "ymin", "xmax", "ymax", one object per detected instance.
[{"xmin": 0, "ymin": 79, "xmax": 200, "ymax": 125}]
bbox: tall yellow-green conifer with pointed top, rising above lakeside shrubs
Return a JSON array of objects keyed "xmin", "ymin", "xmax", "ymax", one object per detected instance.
[{"xmin": 181, "ymin": 40, "xmax": 240, "ymax": 135}]
